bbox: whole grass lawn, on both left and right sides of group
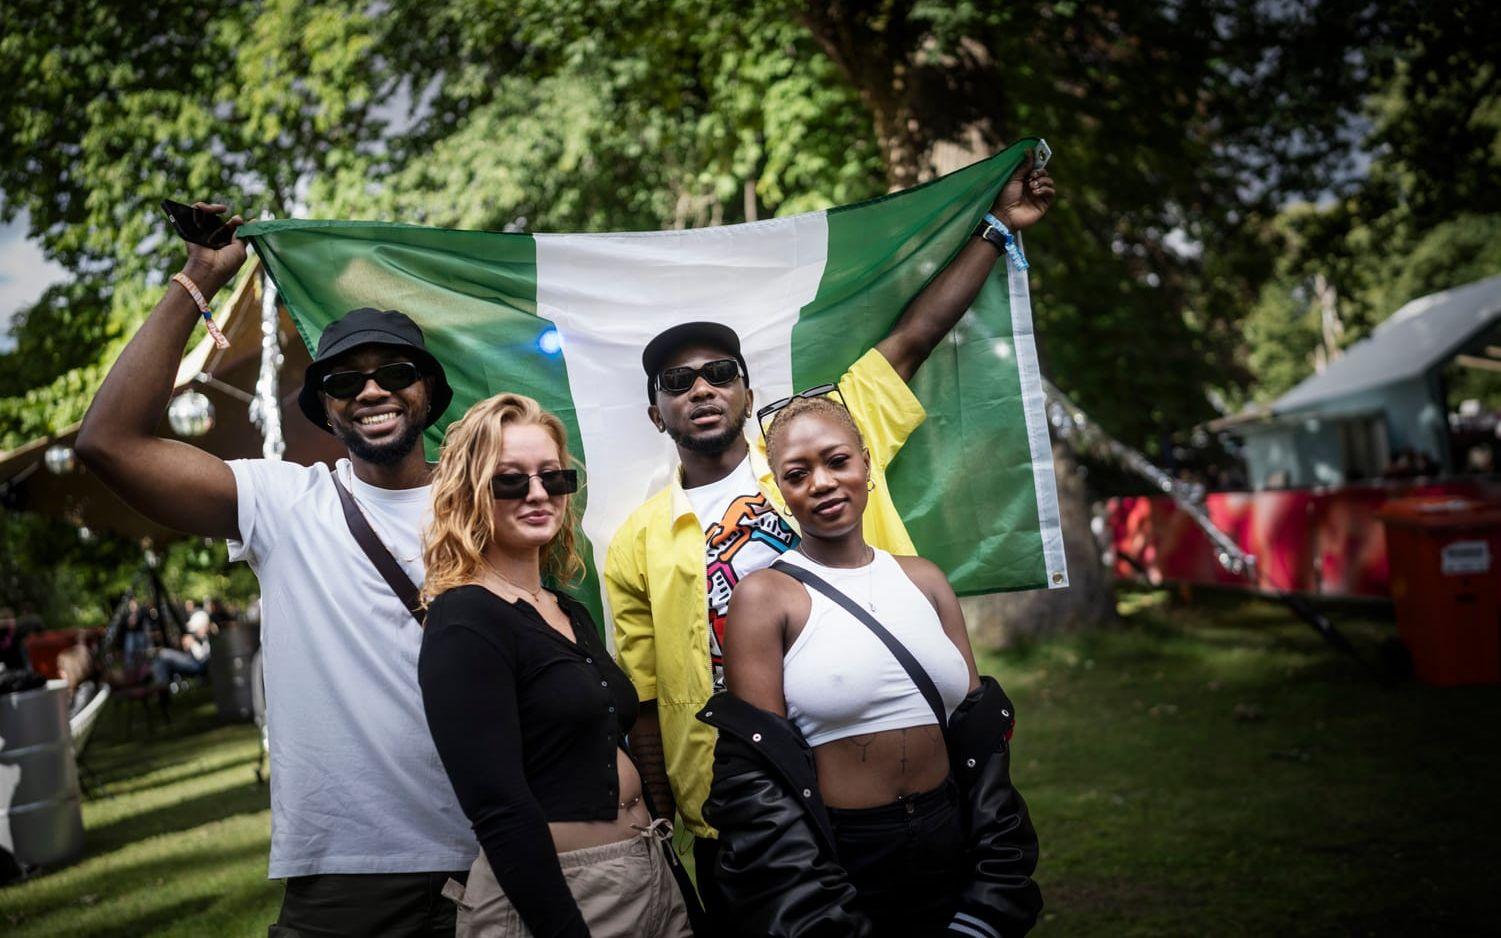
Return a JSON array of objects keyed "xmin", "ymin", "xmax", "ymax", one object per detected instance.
[{"xmin": 0, "ymin": 591, "xmax": 1501, "ymax": 938}]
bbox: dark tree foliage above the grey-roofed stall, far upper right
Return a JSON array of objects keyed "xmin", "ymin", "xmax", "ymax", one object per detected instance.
[{"xmin": 1247, "ymin": 3, "xmax": 1501, "ymax": 399}]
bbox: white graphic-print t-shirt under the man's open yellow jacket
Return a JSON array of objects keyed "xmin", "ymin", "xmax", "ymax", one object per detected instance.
[{"xmin": 683, "ymin": 456, "xmax": 799, "ymax": 690}]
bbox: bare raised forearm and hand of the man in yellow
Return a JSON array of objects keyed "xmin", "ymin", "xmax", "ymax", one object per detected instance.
[{"xmin": 875, "ymin": 153, "xmax": 1054, "ymax": 381}]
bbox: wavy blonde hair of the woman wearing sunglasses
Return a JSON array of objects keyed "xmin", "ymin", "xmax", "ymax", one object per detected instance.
[{"xmin": 422, "ymin": 393, "xmax": 584, "ymax": 599}]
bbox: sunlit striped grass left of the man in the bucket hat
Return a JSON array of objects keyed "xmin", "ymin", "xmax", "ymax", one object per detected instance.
[{"xmin": 0, "ymin": 689, "xmax": 281, "ymax": 938}]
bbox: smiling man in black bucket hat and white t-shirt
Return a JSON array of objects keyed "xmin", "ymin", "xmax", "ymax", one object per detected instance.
[{"xmin": 77, "ymin": 204, "xmax": 477, "ymax": 938}]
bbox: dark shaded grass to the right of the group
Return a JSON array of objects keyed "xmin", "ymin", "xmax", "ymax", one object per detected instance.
[{"xmin": 1008, "ymin": 591, "xmax": 1501, "ymax": 935}]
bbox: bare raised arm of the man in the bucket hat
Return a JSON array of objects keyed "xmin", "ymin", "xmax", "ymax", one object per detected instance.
[{"xmin": 75, "ymin": 203, "xmax": 245, "ymax": 537}]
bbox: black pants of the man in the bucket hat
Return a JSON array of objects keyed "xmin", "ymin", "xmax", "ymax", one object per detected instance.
[{"xmin": 270, "ymin": 869, "xmax": 468, "ymax": 938}]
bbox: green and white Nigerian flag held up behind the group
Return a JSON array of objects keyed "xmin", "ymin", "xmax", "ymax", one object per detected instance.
[{"xmin": 240, "ymin": 140, "xmax": 1067, "ymax": 621}]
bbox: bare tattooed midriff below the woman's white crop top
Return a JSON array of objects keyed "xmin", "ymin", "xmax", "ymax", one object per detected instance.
[{"xmin": 814, "ymin": 725, "xmax": 949, "ymax": 807}]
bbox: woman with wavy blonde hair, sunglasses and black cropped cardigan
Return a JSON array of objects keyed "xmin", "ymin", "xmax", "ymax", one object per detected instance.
[{"xmin": 417, "ymin": 393, "xmax": 690, "ymax": 938}]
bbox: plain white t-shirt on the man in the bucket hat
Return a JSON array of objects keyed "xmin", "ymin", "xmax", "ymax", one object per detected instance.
[{"xmin": 230, "ymin": 459, "xmax": 479, "ymax": 878}]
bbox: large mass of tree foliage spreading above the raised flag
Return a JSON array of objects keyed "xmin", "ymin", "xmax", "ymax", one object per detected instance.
[{"xmin": 0, "ymin": 0, "xmax": 1404, "ymax": 453}]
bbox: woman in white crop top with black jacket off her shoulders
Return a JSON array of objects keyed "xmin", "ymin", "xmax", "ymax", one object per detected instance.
[{"xmin": 698, "ymin": 389, "xmax": 1042, "ymax": 938}]
